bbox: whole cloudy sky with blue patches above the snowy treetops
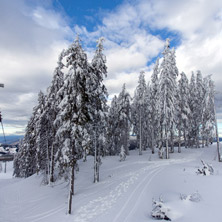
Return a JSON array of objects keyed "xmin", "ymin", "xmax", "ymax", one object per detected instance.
[{"xmin": 0, "ymin": 0, "xmax": 222, "ymax": 134}]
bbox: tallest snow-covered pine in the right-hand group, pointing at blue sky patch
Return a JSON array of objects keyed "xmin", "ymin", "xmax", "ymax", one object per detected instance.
[{"xmin": 159, "ymin": 39, "xmax": 178, "ymax": 159}]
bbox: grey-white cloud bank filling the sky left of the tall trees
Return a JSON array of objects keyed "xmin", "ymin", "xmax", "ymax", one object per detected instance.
[{"xmin": 0, "ymin": 0, "xmax": 73, "ymax": 133}]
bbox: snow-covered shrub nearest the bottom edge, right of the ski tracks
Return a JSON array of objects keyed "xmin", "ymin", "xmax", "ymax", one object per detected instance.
[{"xmin": 151, "ymin": 198, "xmax": 171, "ymax": 221}]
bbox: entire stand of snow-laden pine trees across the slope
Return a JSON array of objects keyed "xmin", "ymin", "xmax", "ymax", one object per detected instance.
[{"xmin": 14, "ymin": 37, "xmax": 215, "ymax": 213}]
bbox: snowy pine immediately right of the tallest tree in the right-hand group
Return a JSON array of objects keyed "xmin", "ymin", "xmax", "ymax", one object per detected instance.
[{"xmin": 176, "ymin": 72, "xmax": 190, "ymax": 153}]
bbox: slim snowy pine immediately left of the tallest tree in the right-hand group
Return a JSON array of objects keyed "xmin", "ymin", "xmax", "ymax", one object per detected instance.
[{"xmin": 147, "ymin": 59, "xmax": 159, "ymax": 153}]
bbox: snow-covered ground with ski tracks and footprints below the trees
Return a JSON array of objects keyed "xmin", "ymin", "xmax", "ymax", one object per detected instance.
[{"xmin": 0, "ymin": 145, "xmax": 222, "ymax": 222}]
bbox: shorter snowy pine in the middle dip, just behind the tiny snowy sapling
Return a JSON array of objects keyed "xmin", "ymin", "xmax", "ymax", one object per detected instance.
[{"xmin": 117, "ymin": 84, "xmax": 130, "ymax": 155}]
